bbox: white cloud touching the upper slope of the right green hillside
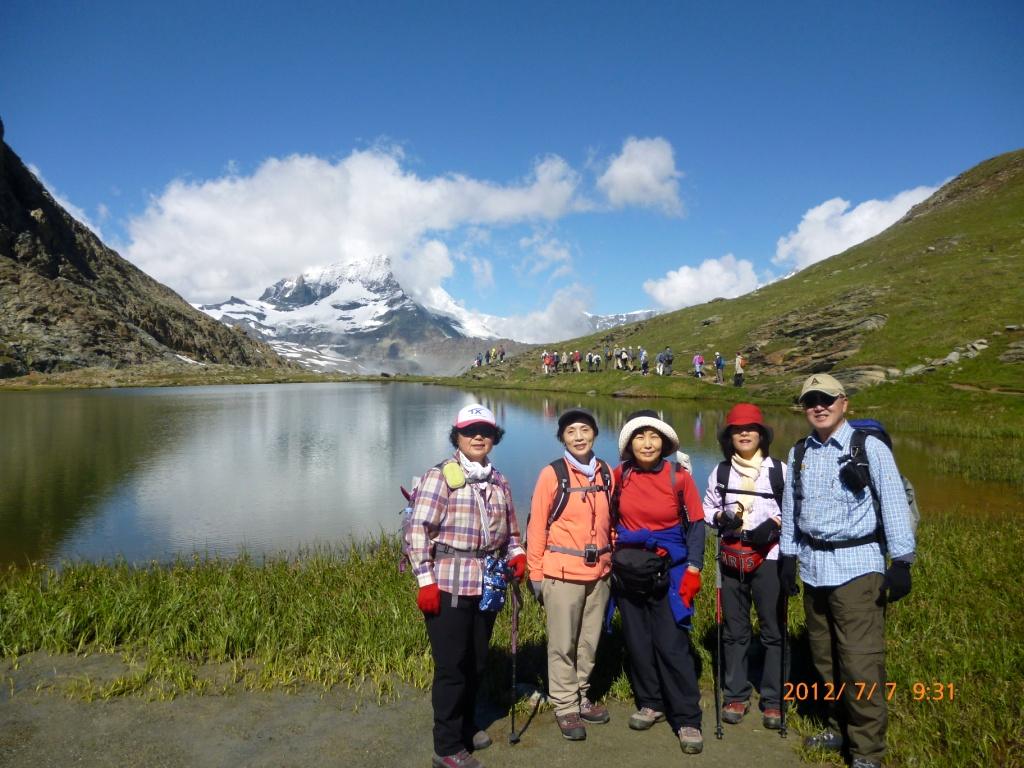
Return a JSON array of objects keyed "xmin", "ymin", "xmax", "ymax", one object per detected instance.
[{"xmin": 772, "ymin": 186, "xmax": 937, "ymax": 269}]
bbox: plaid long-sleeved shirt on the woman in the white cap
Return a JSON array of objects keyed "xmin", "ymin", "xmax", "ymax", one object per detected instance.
[{"xmin": 409, "ymin": 459, "xmax": 525, "ymax": 597}]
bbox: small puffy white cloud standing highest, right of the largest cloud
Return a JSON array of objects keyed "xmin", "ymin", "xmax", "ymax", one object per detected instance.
[{"xmin": 597, "ymin": 136, "xmax": 683, "ymax": 216}]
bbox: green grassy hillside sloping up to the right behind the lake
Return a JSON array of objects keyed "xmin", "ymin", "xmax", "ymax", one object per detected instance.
[{"xmin": 466, "ymin": 151, "xmax": 1024, "ymax": 396}]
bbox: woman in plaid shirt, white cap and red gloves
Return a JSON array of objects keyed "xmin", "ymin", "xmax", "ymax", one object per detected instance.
[{"xmin": 409, "ymin": 404, "xmax": 526, "ymax": 768}]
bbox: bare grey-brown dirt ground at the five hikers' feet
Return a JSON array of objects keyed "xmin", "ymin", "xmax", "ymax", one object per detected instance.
[{"xmin": 0, "ymin": 654, "xmax": 802, "ymax": 768}]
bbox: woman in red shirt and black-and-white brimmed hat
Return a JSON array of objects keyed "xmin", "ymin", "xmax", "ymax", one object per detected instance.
[{"xmin": 612, "ymin": 411, "xmax": 705, "ymax": 755}]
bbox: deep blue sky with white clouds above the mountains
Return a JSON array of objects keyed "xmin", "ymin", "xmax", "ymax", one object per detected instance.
[{"xmin": 0, "ymin": 0, "xmax": 1024, "ymax": 341}]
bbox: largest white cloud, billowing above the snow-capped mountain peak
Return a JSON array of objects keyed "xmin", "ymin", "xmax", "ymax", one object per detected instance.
[{"xmin": 123, "ymin": 147, "xmax": 593, "ymax": 302}]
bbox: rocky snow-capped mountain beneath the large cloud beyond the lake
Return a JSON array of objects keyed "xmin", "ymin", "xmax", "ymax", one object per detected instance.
[{"xmin": 197, "ymin": 256, "xmax": 508, "ymax": 375}]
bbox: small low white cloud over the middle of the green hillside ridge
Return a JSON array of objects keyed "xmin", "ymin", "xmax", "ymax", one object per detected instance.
[{"xmin": 643, "ymin": 253, "xmax": 760, "ymax": 310}]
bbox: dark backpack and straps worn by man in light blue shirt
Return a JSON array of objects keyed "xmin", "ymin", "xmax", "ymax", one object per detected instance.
[{"xmin": 793, "ymin": 419, "xmax": 921, "ymax": 552}]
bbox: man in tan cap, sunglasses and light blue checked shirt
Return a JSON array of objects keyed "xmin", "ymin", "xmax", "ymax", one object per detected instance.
[{"xmin": 779, "ymin": 374, "xmax": 915, "ymax": 768}]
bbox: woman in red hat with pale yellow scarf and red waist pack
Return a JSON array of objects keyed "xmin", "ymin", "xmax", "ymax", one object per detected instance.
[{"xmin": 703, "ymin": 402, "xmax": 785, "ymax": 730}]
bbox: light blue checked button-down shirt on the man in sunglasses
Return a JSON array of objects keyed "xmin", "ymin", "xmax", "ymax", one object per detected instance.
[{"xmin": 779, "ymin": 422, "xmax": 914, "ymax": 587}]
